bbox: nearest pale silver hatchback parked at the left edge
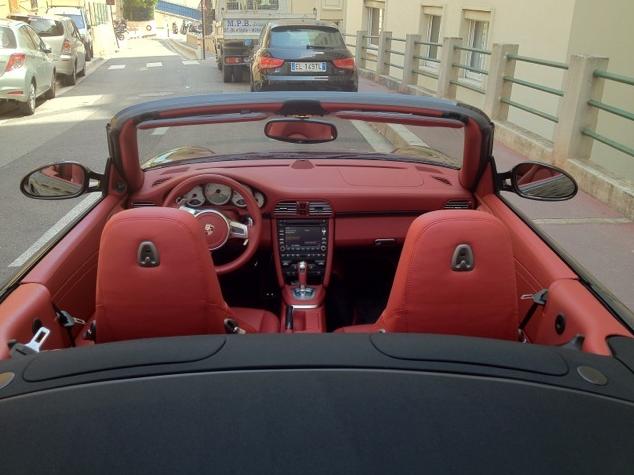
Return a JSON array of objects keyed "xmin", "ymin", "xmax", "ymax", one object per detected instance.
[{"xmin": 0, "ymin": 19, "xmax": 55, "ymax": 115}]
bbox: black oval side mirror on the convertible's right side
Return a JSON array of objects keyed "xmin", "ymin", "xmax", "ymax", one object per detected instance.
[{"xmin": 500, "ymin": 162, "xmax": 578, "ymax": 201}]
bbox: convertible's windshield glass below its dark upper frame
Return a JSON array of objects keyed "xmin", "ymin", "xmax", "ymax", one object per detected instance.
[{"xmin": 137, "ymin": 116, "xmax": 464, "ymax": 168}]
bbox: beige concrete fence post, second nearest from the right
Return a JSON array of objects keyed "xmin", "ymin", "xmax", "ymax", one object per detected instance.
[{"xmin": 482, "ymin": 43, "xmax": 519, "ymax": 120}]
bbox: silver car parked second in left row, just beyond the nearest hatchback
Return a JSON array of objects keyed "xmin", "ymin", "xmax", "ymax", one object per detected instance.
[{"xmin": 9, "ymin": 15, "xmax": 86, "ymax": 86}]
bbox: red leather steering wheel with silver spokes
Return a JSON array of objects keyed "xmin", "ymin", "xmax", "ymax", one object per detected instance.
[{"xmin": 163, "ymin": 173, "xmax": 262, "ymax": 274}]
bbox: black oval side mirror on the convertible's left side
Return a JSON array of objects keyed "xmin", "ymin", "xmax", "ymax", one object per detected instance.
[{"xmin": 20, "ymin": 162, "xmax": 103, "ymax": 200}]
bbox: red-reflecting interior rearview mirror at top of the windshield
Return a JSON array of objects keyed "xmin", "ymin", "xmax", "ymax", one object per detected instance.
[{"xmin": 264, "ymin": 119, "xmax": 337, "ymax": 144}]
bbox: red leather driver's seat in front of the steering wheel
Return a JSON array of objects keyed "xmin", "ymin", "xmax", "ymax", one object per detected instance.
[{"xmin": 95, "ymin": 208, "xmax": 280, "ymax": 342}]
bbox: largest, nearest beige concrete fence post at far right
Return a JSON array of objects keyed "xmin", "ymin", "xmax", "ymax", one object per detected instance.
[{"xmin": 553, "ymin": 55, "xmax": 609, "ymax": 165}]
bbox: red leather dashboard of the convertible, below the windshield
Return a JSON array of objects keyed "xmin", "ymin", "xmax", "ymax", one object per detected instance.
[{"xmin": 130, "ymin": 159, "xmax": 473, "ymax": 245}]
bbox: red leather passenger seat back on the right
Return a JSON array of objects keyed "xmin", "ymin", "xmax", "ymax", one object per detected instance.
[{"xmin": 337, "ymin": 210, "xmax": 519, "ymax": 340}]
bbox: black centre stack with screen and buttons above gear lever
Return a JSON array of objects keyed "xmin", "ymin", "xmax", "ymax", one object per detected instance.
[{"xmin": 277, "ymin": 219, "xmax": 329, "ymax": 285}]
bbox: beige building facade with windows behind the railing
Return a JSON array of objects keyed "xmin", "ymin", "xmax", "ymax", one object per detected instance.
[{"xmin": 343, "ymin": 0, "xmax": 634, "ymax": 184}]
